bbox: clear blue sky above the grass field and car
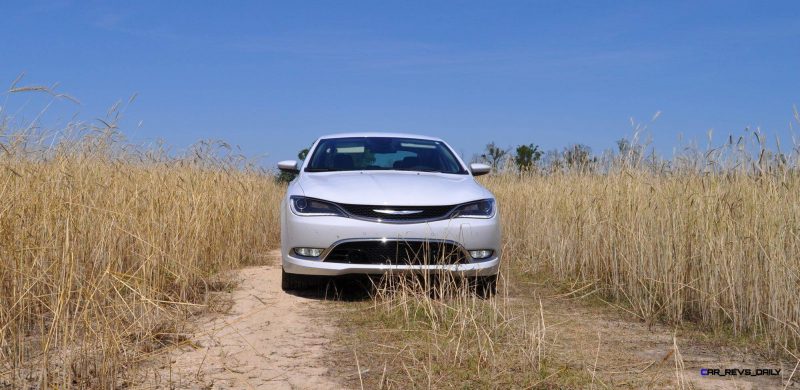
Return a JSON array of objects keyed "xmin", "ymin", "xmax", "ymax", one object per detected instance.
[{"xmin": 0, "ymin": 1, "xmax": 800, "ymax": 163}]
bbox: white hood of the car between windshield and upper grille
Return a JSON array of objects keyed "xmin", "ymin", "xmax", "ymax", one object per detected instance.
[{"xmin": 298, "ymin": 171, "xmax": 493, "ymax": 206}]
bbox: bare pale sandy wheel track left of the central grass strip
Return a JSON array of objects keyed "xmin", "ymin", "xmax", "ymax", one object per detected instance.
[{"xmin": 139, "ymin": 253, "xmax": 341, "ymax": 389}]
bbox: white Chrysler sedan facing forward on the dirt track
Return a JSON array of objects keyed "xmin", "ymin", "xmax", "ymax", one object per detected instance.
[{"xmin": 278, "ymin": 133, "xmax": 501, "ymax": 294}]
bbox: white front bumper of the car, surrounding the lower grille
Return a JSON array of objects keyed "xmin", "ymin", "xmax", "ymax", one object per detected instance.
[{"xmin": 281, "ymin": 204, "xmax": 502, "ymax": 277}]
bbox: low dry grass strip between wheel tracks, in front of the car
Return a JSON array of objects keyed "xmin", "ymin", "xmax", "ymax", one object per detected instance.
[{"xmin": 345, "ymin": 274, "xmax": 560, "ymax": 389}]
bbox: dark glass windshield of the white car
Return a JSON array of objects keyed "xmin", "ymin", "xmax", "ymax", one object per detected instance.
[{"xmin": 305, "ymin": 137, "xmax": 467, "ymax": 175}]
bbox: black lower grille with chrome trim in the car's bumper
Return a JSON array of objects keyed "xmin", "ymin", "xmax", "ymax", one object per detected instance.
[{"xmin": 324, "ymin": 240, "xmax": 467, "ymax": 265}]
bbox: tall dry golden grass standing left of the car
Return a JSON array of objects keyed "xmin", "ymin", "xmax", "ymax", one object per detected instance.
[{"xmin": 0, "ymin": 121, "xmax": 283, "ymax": 388}]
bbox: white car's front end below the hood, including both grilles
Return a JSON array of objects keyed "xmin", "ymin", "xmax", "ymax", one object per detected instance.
[{"xmin": 281, "ymin": 196, "xmax": 501, "ymax": 276}]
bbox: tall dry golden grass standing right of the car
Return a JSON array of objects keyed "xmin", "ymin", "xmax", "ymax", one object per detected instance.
[{"xmin": 485, "ymin": 132, "xmax": 800, "ymax": 352}]
